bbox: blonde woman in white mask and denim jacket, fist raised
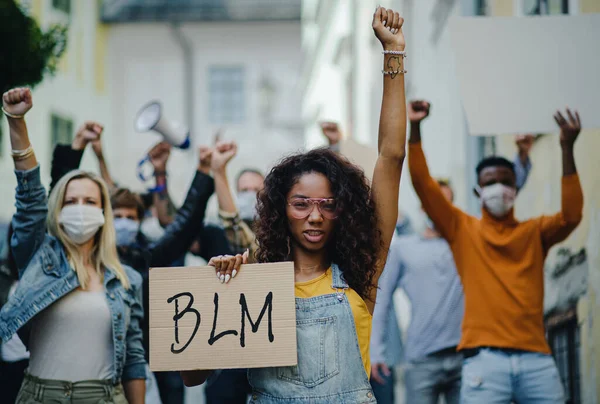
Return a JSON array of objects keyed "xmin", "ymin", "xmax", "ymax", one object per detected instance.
[{"xmin": 0, "ymin": 88, "xmax": 146, "ymax": 404}]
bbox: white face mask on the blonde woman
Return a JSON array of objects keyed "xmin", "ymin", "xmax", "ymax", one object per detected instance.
[{"xmin": 58, "ymin": 204, "xmax": 104, "ymax": 244}]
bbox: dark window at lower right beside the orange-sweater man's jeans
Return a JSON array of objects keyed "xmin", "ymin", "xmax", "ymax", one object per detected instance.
[{"xmin": 546, "ymin": 309, "xmax": 581, "ymax": 404}]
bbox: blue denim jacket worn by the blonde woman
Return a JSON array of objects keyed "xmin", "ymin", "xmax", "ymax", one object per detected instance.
[{"xmin": 0, "ymin": 166, "xmax": 146, "ymax": 383}]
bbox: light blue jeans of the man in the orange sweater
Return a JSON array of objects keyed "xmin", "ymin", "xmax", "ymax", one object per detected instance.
[{"xmin": 460, "ymin": 348, "xmax": 565, "ymax": 404}]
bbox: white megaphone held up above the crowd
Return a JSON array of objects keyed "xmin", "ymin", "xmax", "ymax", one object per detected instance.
[{"xmin": 134, "ymin": 101, "xmax": 190, "ymax": 192}]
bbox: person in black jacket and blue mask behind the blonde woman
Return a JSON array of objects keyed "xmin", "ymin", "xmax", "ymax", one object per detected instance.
[{"xmin": 51, "ymin": 136, "xmax": 214, "ymax": 404}]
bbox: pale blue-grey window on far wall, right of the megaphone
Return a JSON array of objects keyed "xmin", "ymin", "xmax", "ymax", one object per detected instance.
[{"xmin": 208, "ymin": 66, "xmax": 246, "ymax": 124}]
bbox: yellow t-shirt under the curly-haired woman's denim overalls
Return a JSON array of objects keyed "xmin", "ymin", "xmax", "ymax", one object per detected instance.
[{"xmin": 295, "ymin": 268, "xmax": 373, "ymax": 377}]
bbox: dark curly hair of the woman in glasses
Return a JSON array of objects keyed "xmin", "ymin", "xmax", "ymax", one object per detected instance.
[{"xmin": 254, "ymin": 148, "xmax": 381, "ymax": 299}]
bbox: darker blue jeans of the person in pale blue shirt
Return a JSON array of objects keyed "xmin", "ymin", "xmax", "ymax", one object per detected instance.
[{"xmin": 404, "ymin": 352, "xmax": 464, "ymax": 404}]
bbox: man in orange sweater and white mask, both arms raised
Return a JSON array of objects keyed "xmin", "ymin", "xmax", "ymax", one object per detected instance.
[{"xmin": 408, "ymin": 97, "xmax": 583, "ymax": 404}]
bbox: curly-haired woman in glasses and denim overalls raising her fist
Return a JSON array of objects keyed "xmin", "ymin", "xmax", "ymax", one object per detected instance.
[{"xmin": 182, "ymin": 7, "xmax": 406, "ymax": 403}]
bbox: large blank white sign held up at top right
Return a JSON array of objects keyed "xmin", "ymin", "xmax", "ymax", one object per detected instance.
[{"xmin": 450, "ymin": 14, "xmax": 600, "ymax": 135}]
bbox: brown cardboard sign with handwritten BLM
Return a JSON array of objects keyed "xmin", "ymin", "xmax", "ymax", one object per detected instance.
[{"xmin": 150, "ymin": 262, "xmax": 298, "ymax": 371}]
